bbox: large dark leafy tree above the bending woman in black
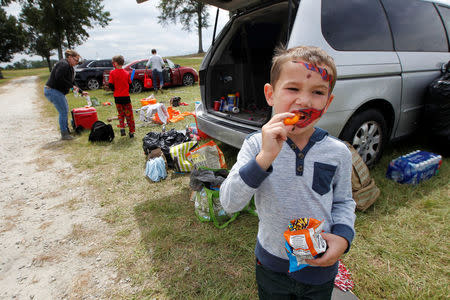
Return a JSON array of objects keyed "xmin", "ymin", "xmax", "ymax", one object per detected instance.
[{"xmin": 21, "ymin": 0, "xmax": 111, "ymax": 59}]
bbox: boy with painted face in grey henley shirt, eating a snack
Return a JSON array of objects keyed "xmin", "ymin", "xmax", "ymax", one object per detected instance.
[{"xmin": 220, "ymin": 47, "xmax": 355, "ymax": 299}]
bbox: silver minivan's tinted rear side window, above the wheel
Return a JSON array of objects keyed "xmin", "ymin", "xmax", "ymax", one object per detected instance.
[{"xmin": 322, "ymin": 0, "xmax": 394, "ymax": 51}]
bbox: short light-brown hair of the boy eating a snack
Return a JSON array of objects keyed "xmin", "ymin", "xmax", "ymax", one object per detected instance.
[{"xmin": 270, "ymin": 46, "xmax": 337, "ymax": 93}]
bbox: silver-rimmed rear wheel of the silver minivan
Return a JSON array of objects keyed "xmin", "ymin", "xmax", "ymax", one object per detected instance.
[{"xmin": 340, "ymin": 109, "xmax": 387, "ymax": 167}]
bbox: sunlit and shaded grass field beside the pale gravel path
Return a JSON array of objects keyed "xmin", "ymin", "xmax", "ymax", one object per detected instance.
[{"xmin": 8, "ymin": 57, "xmax": 450, "ymax": 299}]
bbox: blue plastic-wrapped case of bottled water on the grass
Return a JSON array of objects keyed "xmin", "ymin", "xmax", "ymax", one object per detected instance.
[{"xmin": 386, "ymin": 150, "xmax": 442, "ymax": 184}]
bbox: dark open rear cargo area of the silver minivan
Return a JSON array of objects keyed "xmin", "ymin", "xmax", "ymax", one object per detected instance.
[{"xmin": 200, "ymin": 1, "xmax": 296, "ymax": 127}]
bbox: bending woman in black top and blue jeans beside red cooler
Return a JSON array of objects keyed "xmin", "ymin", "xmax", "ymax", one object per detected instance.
[{"xmin": 44, "ymin": 49, "xmax": 88, "ymax": 140}]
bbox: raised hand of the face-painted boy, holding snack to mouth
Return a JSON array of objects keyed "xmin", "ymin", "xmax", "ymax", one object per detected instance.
[{"xmin": 256, "ymin": 112, "xmax": 294, "ymax": 170}]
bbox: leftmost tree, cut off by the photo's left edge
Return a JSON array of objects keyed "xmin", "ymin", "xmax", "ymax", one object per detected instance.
[{"xmin": 0, "ymin": 5, "xmax": 27, "ymax": 78}]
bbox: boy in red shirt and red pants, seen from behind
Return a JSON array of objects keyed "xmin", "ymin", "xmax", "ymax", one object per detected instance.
[{"xmin": 109, "ymin": 55, "xmax": 135, "ymax": 138}]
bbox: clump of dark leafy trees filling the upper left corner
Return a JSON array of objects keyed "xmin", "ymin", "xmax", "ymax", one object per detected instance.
[{"xmin": 0, "ymin": 0, "xmax": 111, "ymax": 78}]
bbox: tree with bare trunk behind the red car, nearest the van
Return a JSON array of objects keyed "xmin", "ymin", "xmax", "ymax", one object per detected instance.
[{"xmin": 158, "ymin": 0, "xmax": 209, "ymax": 53}]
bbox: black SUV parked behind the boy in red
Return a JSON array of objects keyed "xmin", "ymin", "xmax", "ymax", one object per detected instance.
[{"xmin": 75, "ymin": 59, "xmax": 114, "ymax": 90}]
